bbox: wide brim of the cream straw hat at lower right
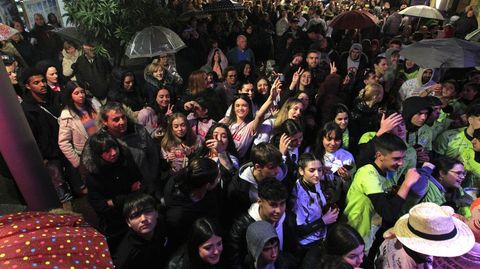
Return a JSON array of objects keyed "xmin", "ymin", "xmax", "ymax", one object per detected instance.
[{"xmin": 394, "ymin": 214, "xmax": 475, "ymax": 257}]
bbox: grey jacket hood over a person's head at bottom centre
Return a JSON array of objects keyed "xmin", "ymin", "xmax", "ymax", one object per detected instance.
[{"xmin": 246, "ymin": 221, "xmax": 278, "ymax": 265}]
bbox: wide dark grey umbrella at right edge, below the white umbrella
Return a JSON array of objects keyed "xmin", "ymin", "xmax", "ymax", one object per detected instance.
[{"xmin": 400, "ymin": 38, "xmax": 480, "ymax": 68}]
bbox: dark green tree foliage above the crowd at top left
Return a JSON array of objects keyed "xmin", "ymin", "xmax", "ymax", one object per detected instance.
[{"xmin": 64, "ymin": 0, "xmax": 175, "ymax": 65}]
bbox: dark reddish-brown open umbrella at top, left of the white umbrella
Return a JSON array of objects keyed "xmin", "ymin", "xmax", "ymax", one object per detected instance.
[{"xmin": 330, "ymin": 10, "xmax": 378, "ymax": 29}]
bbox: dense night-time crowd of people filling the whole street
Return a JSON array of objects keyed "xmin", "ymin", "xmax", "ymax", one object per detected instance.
[{"xmin": 1, "ymin": 0, "xmax": 480, "ymax": 269}]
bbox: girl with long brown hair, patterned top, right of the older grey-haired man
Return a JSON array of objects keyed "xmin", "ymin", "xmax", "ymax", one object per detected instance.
[{"xmin": 161, "ymin": 113, "xmax": 201, "ymax": 174}]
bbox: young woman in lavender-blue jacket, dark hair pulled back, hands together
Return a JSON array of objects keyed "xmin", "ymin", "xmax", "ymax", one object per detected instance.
[{"xmin": 292, "ymin": 153, "xmax": 339, "ymax": 248}]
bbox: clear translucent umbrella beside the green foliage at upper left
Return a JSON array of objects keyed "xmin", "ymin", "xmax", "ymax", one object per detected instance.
[{"xmin": 125, "ymin": 26, "xmax": 186, "ymax": 58}]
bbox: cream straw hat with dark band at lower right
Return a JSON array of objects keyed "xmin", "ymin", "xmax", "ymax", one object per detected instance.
[{"xmin": 393, "ymin": 202, "xmax": 474, "ymax": 257}]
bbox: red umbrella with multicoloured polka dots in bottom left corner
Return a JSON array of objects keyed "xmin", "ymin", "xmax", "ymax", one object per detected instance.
[{"xmin": 0, "ymin": 212, "xmax": 113, "ymax": 269}]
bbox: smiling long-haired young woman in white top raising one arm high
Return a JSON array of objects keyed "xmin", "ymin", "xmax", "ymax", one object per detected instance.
[{"xmin": 220, "ymin": 79, "xmax": 281, "ymax": 159}]
